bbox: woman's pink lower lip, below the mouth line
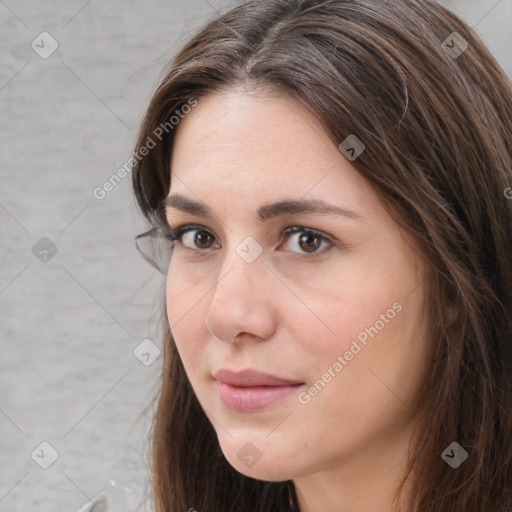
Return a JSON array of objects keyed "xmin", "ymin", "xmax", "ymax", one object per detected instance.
[{"xmin": 215, "ymin": 380, "xmax": 302, "ymax": 412}]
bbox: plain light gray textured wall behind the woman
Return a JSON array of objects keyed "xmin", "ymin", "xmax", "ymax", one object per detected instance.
[{"xmin": 0, "ymin": 0, "xmax": 512, "ymax": 512}]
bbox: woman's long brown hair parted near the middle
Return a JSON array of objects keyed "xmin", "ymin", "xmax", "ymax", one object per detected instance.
[{"xmin": 133, "ymin": 0, "xmax": 512, "ymax": 512}]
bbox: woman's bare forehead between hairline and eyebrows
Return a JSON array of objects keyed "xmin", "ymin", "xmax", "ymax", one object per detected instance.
[{"xmin": 170, "ymin": 91, "xmax": 372, "ymax": 209}]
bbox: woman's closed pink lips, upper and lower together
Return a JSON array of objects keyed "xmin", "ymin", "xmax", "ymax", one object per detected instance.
[{"xmin": 213, "ymin": 369, "xmax": 304, "ymax": 412}]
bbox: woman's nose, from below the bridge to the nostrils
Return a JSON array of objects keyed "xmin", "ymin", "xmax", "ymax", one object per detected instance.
[{"xmin": 206, "ymin": 249, "xmax": 276, "ymax": 343}]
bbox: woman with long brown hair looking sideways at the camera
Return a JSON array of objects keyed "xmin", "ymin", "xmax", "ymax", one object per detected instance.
[{"xmin": 133, "ymin": 0, "xmax": 512, "ymax": 512}]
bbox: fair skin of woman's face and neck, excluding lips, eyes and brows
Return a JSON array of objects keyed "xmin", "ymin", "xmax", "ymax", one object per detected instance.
[{"xmin": 166, "ymin": 89, "xmax": 431, "ymax": 512}]
